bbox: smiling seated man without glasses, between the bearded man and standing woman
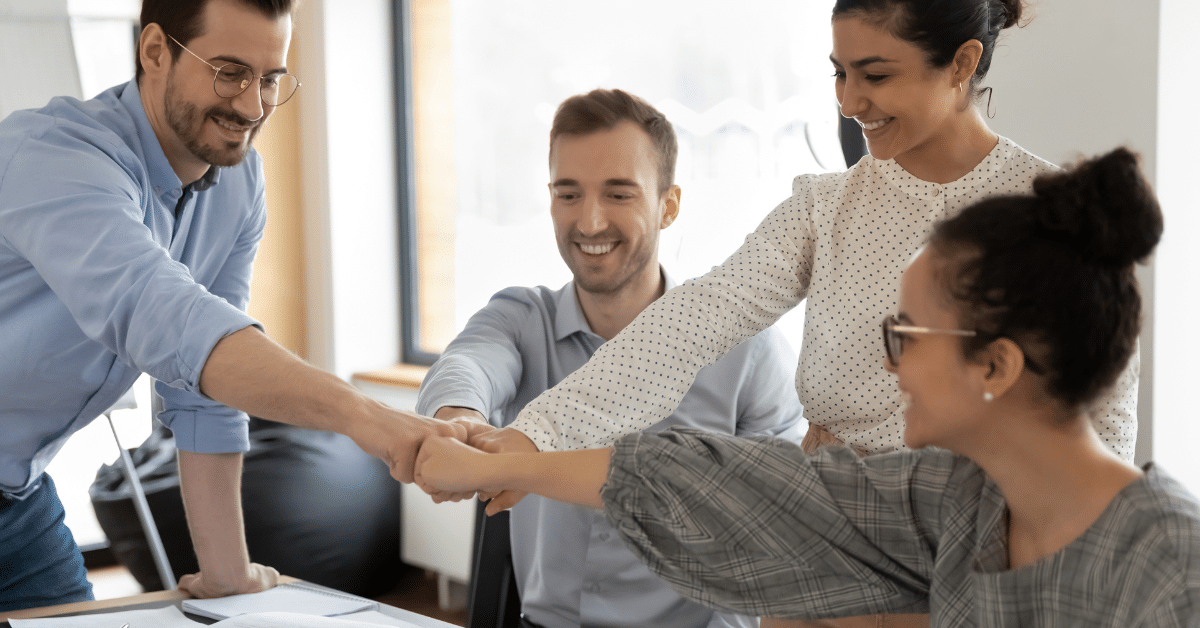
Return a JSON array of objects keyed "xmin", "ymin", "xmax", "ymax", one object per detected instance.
[{"xmin": 416, "ymin": 90, "xmax": 800, "ymax": 628}]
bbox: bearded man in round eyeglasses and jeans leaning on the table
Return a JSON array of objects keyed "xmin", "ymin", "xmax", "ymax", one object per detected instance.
[{"xmin": 0, "ymin": 0, "xmax": 466, "ymax": 610}]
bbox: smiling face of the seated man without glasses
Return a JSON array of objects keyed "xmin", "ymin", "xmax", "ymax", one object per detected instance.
[{"xmin": 550, "ymin": 120, "xmax": 679, "ymax": 302}]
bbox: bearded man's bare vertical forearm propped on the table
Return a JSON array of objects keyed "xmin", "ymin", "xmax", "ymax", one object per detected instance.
[{"xmin": 179, "ymin": 450, "xmax": 250, "ymax": 593}]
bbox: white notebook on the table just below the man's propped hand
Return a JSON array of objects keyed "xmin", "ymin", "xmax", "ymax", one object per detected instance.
[{"xmin": 182, "ymin": 582, "xmax": 379, "ymax": 620}]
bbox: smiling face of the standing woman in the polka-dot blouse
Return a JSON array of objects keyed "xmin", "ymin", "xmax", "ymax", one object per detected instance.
[{"xmin": 829, "ymin": 13, "xmax": 970, "ymax": 167}]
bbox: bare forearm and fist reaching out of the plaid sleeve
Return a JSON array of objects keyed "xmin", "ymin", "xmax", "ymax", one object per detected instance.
[{"xmin": 414, "ymin": 438, "xmax": 612, "ymax": 508}]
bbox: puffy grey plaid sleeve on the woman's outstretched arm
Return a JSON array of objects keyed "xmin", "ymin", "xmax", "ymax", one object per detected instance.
[{"xmin": 601, "ymin": 429, "xmax": 961, "ymax": 618}]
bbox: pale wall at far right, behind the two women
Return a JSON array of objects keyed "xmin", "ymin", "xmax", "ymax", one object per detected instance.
[{"xmin": 989, "ymin": 0, "xmax": 1200, "ymax": 494}]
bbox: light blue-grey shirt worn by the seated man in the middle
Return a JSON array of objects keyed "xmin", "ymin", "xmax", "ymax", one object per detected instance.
[{"xmin": 416, "ymin": 274, "xmax": 802, "ymax": 628}]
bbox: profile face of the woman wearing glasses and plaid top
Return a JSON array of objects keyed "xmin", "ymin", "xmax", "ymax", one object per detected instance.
[{"xmin": 884, "ymin": 249, "xmax": 989, "ymax": 453}]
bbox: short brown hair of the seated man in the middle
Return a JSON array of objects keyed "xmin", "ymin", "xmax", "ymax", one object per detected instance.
[{"xmin": 550, "ymin": 89, "xmax": 679, "ymax": 196}]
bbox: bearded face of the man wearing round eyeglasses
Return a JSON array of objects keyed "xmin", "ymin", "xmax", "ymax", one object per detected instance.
[{"xmin": 142, "ymin": 0, "xmax": 292, "ymax": 183}]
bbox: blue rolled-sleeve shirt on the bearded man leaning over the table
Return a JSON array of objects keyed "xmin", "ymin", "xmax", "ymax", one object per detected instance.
[{"xmin": 0, "ymin": 82, "xmax": 266, "ymax": 496}]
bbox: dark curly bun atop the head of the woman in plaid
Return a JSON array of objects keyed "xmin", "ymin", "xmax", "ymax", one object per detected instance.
[{"xmin": 1033, "ymin": 148, "xmax": 1163, "ymax": 267}]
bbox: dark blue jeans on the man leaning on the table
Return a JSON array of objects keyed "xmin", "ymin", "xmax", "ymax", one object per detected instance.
[{"xmin": 0, "ymin": 473, "xmax": 94, "ymax": 610}]
